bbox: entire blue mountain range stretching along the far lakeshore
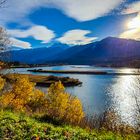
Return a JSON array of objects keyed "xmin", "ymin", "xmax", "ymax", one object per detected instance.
[{"xmin": 1, "ymin": 37, "xmax": 140, "ymax": 66}]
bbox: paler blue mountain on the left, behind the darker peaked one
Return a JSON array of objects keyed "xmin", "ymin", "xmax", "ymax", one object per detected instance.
[{"xmin": 2, "ymin": 43, "xmax": 69, "ymax": 64}]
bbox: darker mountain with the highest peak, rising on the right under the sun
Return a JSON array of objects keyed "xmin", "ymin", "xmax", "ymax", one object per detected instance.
[{"xmin": 46, "ymin": 37, "xmax": 140, "ymax": 64}]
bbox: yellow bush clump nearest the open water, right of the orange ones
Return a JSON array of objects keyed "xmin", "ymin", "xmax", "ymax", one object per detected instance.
[{"xmin": 47, "ymin": 82, "xmax": 84, "ymax": 123}]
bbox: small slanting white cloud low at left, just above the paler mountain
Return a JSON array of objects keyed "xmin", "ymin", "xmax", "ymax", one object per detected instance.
[{"xmin": 10, "ymin": 38, "xmax": 31, "ymax": 49}]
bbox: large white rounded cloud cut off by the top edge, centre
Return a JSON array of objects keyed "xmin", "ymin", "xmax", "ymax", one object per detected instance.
[{"xmin": 52, "ymin": 0, "xmax": 124, "ymax": 21}]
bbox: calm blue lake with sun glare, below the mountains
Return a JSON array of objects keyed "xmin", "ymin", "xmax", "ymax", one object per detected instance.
[{"xmin": 5, "ymin": 65, "xmax": 140, "ymax": 125}]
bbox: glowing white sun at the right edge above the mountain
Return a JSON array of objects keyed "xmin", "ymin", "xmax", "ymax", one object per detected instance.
[{"xmin": 127, "ymin": 16, "xmax": 140, "ymax": 29}]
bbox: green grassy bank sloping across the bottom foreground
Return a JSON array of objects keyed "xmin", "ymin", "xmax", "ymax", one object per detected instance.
[{"xmin": 0, "ymin": 110, "xmax": 140, "ymax": 140}]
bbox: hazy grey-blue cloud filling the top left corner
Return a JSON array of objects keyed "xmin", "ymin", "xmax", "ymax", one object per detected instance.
[{"xmin": 0, "ymin": 0, "xmax": 45, "ymax": 25}]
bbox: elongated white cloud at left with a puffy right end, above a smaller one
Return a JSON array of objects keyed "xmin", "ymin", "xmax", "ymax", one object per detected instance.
[{"xmin": 8, "ymin": 25, "xmax": 55, "ymax": 43}]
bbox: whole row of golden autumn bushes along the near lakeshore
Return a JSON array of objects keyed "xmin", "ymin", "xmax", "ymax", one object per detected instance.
[{"xmin": 0, "ymin": 76, "xmax": 138, "ymax": 138}]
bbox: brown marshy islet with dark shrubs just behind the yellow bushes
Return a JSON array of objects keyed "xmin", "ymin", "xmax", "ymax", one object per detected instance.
[{"xmin": 3, "ymin": 74, "xmax": 82, "ymax": 87}]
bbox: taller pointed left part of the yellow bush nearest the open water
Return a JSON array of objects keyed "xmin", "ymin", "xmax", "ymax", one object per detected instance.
[{"xmin": 46, "ymin": 82, "xmax": 69, "ymax": 119}]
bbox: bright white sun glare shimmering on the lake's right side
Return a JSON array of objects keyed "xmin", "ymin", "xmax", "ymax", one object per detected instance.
[{"xmin": 107, "ymin": 76, "xmax": 140, "ymax": 125}]
